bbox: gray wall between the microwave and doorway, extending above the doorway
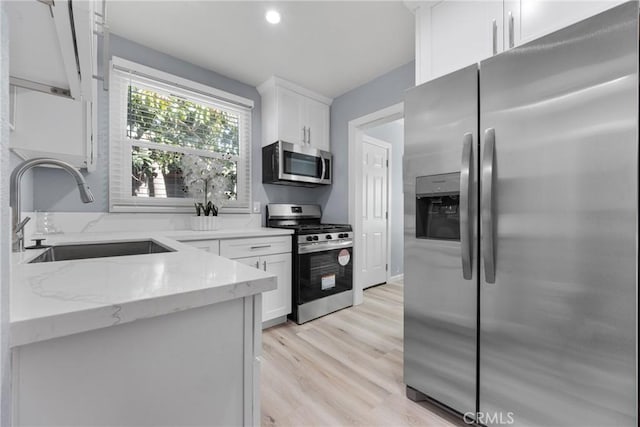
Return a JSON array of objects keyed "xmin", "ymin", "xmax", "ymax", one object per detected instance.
[{"xmin": 323, "ymin": 61, "xmax": 415, "ymax": 227}]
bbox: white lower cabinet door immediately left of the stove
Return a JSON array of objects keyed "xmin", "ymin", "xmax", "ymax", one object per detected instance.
[{"xmin": 260, "ymin": 254, "xmax": 291, "ymax": 322}]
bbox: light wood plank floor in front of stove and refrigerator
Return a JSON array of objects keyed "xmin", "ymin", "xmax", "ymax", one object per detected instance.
[{"xmin": 261, "ymin": 283, "xmax": 464, "ymax": 427}]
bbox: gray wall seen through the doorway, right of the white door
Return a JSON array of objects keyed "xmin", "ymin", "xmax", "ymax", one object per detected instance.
[{"xmin": 365, "ymin": 119, "xmax": 404, "ymax": 276}]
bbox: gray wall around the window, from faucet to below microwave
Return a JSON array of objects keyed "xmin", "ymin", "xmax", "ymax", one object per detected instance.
[{"xmin": 33, "ymin": 35, "xmax": 328, "ymax": 217}]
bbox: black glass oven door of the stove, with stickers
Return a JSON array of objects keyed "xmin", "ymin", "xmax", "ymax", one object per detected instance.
[{"xmin": 293, "ymin": 242, "xmax": 353, "ymax": 305}]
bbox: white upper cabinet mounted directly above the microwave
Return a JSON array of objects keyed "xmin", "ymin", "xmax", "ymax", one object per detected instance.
[{"xmin": 258, "ymin": 77, "xmax": 332, "ymax": 151}]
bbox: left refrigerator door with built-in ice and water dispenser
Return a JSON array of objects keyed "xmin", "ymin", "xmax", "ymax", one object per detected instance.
[{"xmin": 404, "ymin": 65, "xmax": 478, "ymax": 413}]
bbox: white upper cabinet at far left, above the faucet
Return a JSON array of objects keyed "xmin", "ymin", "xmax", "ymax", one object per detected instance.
[{"xmin": 4, "ymin": 0, "xmax": 97, "ymax": 170}]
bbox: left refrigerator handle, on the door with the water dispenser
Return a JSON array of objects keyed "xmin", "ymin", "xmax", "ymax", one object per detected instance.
[{"xmin": 460, "ymin": 132, "xmax": 473, "ymax": 280}]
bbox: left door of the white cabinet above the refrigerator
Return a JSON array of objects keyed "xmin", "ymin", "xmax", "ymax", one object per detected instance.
[{"xmin": 428, "ymin": 1, "xmax": 503, "ymax": 79}]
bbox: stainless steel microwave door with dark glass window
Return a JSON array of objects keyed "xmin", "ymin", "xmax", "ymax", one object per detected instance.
[{"xmin": 279, "ymin": 141, "xmax": 332, "ymax": 184}]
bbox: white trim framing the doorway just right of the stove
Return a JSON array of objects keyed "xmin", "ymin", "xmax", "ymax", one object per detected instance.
[{"xmin": 347, "ymin": 102, "xmax": 404, "ymax": 305}]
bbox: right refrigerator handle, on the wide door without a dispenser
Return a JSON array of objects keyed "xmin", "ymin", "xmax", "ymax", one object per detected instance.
[{"xmin": 480, "ymin": 128, "xmax": 496, "ymax": 283}]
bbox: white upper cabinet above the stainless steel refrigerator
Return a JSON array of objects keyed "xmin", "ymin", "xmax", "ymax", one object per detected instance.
[{"xmin": 413, "ymin": 0, "xmax": 622, "ymax": 84}]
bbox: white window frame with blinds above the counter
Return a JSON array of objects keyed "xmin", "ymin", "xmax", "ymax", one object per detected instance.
[{"xmin": 109, "ymin": 56, "xmax": 254, "ymax": 214}]
